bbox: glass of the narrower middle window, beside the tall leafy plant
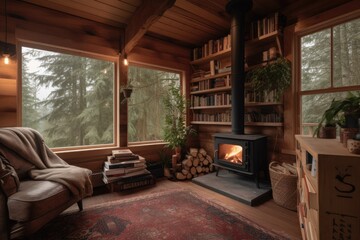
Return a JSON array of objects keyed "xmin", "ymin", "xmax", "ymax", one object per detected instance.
[{"xmin": 128, "ymin": 66, "xmax": 180, "ymax": 142}]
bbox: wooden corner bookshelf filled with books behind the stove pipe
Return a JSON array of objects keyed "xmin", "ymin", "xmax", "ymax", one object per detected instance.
[{"xmin": 190, "ymin": 13, "xmax": 283, "ymax": 127}]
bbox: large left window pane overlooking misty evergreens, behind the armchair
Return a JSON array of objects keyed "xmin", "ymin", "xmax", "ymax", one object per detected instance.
[{"xmin": 21, "ymin": 46, "xmax": 115, "ymax": 148}]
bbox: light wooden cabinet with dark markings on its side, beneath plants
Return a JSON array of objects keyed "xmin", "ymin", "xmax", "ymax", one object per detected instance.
[{"xmin": 295, "ymin": 135, "xmax": 360, "ymax": 240}]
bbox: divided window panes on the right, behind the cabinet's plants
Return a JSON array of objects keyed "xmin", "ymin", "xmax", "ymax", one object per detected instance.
[{"xmin": 300, "ymin": 19, "xmax": 360, "ymax": 134}]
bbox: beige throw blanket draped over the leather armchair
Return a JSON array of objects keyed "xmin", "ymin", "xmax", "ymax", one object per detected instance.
[{"xmin": 0, "ymin": 127, "xmax": 93, "ymax": 198}]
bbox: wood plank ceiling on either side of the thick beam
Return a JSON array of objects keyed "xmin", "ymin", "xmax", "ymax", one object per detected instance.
[{"xmin": 23, "ymin": 0, "xmax": 349, "ymax": 47}]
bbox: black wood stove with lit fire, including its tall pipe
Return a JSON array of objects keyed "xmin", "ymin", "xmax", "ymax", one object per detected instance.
[{"xmin": 214, "ymin": 0, "xmax": 267, "ymax": 188}]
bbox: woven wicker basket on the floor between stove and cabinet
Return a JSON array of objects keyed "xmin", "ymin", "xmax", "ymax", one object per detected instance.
[{"xmin": 269, "ymin": 161, "xmax": 297, "ymax": 211}]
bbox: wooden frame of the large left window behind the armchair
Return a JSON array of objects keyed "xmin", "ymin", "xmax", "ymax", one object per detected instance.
[{"xmin": 17, "ymin": 39, "xmax": 120, "ymax": 153}]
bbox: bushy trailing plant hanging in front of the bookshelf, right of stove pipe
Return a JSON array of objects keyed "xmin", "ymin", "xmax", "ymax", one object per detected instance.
[{"xmin": 246, "ymin": 57, "xmax": 291, "ymax": 101}]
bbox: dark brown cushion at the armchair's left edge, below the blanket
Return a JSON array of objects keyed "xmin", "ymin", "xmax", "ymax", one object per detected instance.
[{"xmin": 0, "ymin": 154, "xmax": 20, "ymax": 197}]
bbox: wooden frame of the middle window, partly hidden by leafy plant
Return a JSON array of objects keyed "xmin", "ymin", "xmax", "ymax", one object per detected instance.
[{"xmin": 126, "ymin": 61, "xmax": 184, "ymax": 147}]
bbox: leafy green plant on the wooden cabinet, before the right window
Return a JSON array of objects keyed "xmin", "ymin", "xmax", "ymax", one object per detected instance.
[{"xmin": 314, "ymin": 92, "xmax": 360, "ymax": 138}]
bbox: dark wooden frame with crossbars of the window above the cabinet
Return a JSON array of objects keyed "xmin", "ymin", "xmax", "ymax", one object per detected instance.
[{"xmin": 293, "ymin": 11, "xmax": 360, "ymax": 134}]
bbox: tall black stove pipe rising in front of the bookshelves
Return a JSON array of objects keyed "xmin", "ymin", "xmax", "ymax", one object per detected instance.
[{"xmin": 226, "ymin": 0, "xmax": 252, "ymax": 134}]
